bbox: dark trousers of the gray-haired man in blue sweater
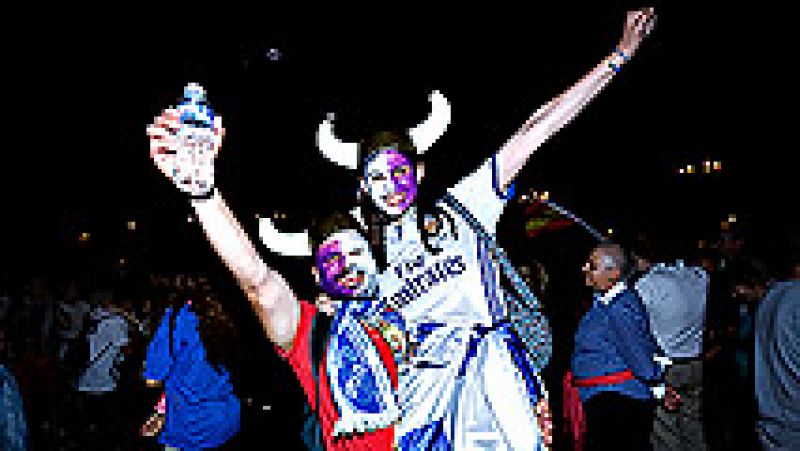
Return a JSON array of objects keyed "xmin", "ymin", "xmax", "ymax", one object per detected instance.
[{"xmin": 583, "ymin": 392, "xmax": 655, "ymax": 451}]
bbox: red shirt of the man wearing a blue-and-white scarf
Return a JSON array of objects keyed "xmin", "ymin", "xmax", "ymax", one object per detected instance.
[{"xmin": 275, "ymin": 301, "xmax": 397, "ymax": 451}]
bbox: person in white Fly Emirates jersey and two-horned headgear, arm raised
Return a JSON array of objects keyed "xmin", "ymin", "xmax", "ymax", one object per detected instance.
[{"xmin": 317, "ymin": 8, "xmax": 654, "ymax": 450}]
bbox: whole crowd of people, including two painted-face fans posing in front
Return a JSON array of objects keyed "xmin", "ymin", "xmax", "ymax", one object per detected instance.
[{"xmin": 0, "ymin": 8, "xmax": 800, "ymax": 450}]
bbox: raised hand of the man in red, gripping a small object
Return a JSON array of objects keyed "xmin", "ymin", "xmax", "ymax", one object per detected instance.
[{"xmin": 147, "ymin": 108, "xmax": 225, "ymax": 196}]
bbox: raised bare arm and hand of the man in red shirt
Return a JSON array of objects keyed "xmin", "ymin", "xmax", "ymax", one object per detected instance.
[{"xmin": 147, "ymin": 104, "xmax": 300, "ymax": 350}]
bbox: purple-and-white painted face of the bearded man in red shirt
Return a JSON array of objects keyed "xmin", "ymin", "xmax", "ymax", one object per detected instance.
[{"xmin": 316, "ymin": 230, "xmax": 378, "ymax": 298}]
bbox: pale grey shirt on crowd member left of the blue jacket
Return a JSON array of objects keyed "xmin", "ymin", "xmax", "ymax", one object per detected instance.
[{"xmin": 76, "ymin": 308, "xmax": 128, "ymax": 393}]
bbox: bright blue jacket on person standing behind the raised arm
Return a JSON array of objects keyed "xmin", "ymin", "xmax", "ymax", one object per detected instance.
[{"xmin": 144, "ymin": 300, "xmax": 241, "ymax": 450}]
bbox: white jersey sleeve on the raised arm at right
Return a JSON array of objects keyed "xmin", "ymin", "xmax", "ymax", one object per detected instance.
[{"xmin": 448, "ymin": 157, "xmax": 514, "ymax": 233}]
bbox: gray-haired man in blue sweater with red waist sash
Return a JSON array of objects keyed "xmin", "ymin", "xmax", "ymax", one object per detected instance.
[{"xmin": 564, "ymin": 243, "xmax": 677, "ymax": 450}]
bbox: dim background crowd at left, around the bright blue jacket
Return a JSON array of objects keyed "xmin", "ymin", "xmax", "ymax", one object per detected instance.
[{"xmin": 0, "ymin": 274, "xmax": 247, "ymax": 450}]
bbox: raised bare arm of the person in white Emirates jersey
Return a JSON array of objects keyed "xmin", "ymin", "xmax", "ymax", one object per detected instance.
[{"xmin": 497, "ymin": 8, "xmax": 655, "ymax": 188}]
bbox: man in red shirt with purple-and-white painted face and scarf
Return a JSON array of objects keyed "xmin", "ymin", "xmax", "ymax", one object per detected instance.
[{"xmin": 148, "ymin": 85, "xmax": 402, "ymax": 450}]
